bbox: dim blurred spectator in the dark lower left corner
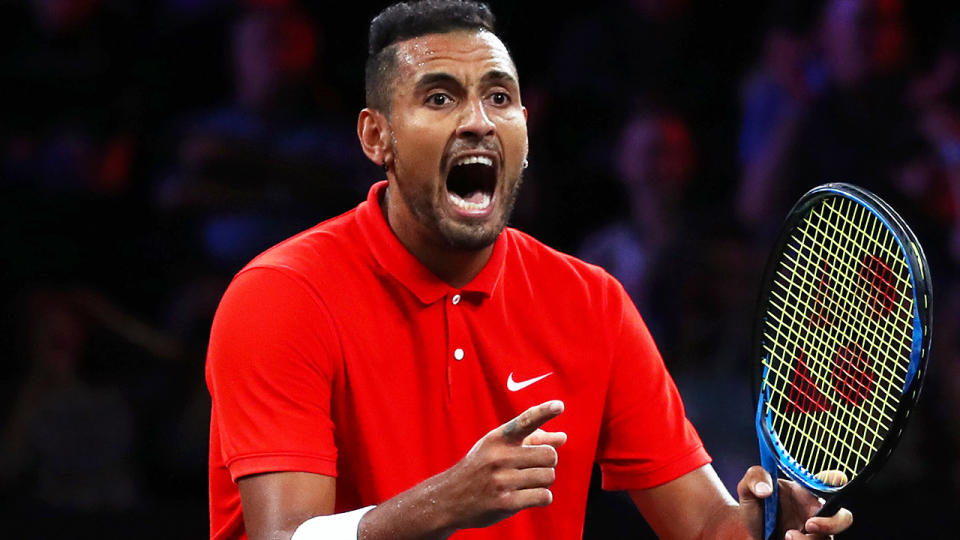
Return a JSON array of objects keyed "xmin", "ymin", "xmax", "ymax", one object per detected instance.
[{"xmin": 0, "ymin": 290, "xmax": 142, "ymax": 513}]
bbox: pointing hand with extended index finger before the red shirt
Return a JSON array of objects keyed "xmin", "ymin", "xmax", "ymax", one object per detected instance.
[{"xmin": 437, "ymin": 401, "xmax": 567, "ymax": 530}]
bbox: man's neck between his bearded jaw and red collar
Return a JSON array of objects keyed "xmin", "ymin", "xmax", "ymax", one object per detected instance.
[{"xmin": 380, "ymin": 188, "xmax": 493, "ymax": 288}]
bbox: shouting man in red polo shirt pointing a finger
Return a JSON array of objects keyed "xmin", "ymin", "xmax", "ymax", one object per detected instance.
[{"xmin": 207, "ymin": 0, "xmax": 852, "ymax": 540}]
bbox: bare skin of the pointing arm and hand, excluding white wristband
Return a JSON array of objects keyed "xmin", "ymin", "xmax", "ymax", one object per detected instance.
[{"xmin": 238, "ymin": 401, "xmax": 566, "ymax": 540}]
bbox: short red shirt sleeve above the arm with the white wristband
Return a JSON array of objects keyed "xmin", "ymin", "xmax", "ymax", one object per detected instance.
[{"xmin": 207, "ymin": 267, "xmax": 341, "ymax": 481}]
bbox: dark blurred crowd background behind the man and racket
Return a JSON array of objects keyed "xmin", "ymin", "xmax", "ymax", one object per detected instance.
[{"xmin": 0, "ymin": 0, "xmax": 960, "ymax": 538}]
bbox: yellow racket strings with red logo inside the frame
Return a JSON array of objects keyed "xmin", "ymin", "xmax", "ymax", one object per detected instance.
[{"xmin": 764, "ymin": 198, "xmax": 913, "ymax": 477}]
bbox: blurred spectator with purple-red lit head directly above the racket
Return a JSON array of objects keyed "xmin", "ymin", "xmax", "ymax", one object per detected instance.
[{"xmin": 739, "ymin": 0, "xmax": 922, "ymax": 236}]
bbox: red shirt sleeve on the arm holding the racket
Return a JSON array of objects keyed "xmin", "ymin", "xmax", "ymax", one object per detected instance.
[{"xmin": 597, "ymin": 278, "xmax": 710, "ymax": 490}]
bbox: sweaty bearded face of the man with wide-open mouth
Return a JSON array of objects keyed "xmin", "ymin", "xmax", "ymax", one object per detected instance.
[{"xmin": 387, "ymin": 31, "xmax": 527, "ymax": 250}]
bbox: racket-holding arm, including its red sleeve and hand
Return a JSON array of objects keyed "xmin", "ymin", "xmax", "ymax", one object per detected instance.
[{"xmin": 597, "ymin": 280, "xmax": 853, "ymax": 540}]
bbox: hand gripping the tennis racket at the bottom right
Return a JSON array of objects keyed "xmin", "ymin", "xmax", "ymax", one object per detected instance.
[{"xmin": 737, "ymin": 465, "xmax": 853, "ymax": 540}]
